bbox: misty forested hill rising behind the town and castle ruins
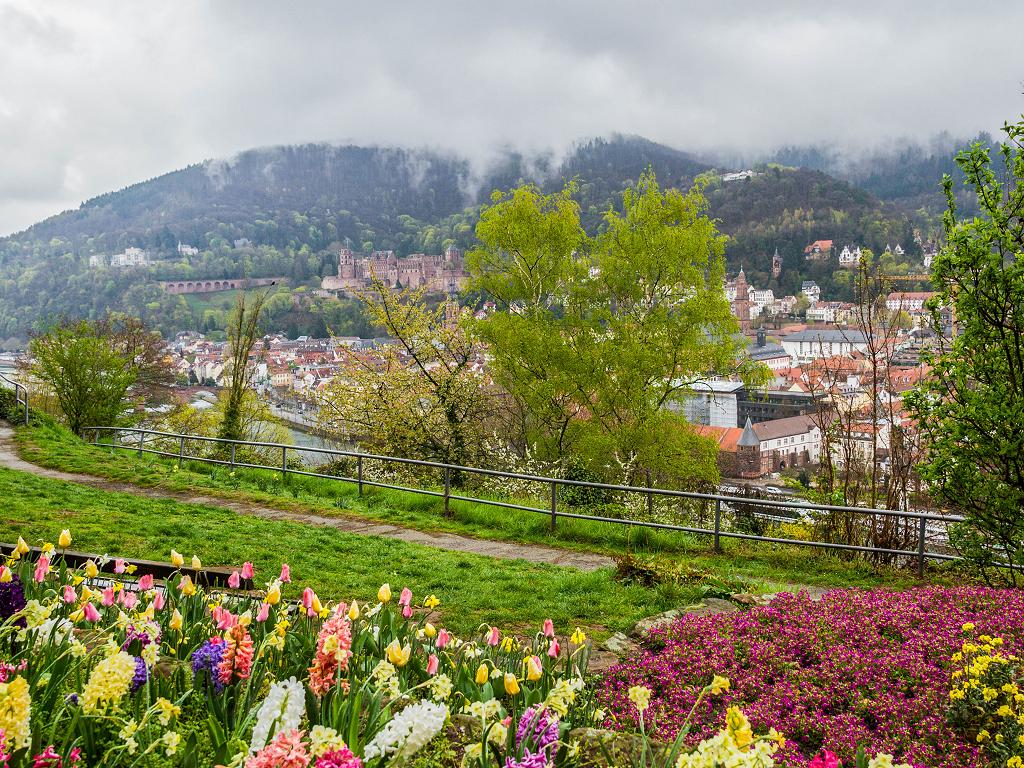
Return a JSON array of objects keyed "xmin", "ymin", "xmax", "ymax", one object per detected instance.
[{"xmin": 0, "ymin": 136, "xmax": 929, "ymax": 346}]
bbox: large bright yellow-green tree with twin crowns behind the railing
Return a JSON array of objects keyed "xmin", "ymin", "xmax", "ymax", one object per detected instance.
[{"xmin": 467, "ymin": 171, "xmax": 759, "ymax": 483}]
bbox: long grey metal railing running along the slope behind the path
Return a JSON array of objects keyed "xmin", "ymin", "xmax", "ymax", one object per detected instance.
[{"xmin": 85, "ymin": 427, "xmax": 964, "ymax": 575}]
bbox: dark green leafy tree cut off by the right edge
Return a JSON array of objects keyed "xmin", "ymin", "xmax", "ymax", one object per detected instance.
[{"xmin": 907, "ymin": 121, "xmax": 1024, "ymax": 584}]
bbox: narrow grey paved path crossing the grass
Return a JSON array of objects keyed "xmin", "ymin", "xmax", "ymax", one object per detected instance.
[{"xmin": 0, "ymin": 426, "xmax": 614, "ymax": 570}]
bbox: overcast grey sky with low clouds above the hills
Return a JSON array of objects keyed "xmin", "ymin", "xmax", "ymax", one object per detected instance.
[{"xmin": 0, "ymin": 0, "xmax": 1024, "ymax": 234}]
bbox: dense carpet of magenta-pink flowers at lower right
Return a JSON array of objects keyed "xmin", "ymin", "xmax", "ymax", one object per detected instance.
[{"xmin": 598, "ymin": 588, "xmax": 1024, "ymax": 768}]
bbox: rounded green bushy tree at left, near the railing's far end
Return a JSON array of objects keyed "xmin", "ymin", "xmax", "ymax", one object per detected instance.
[{"xmin": 28, "ymin": 316, "xmax": 173, "ymax": 434}]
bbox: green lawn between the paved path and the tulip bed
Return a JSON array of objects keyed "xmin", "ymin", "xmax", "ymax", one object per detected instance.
[{"xmin": 0, "ymin": 462, "xmax": 699, "ymax": 636}]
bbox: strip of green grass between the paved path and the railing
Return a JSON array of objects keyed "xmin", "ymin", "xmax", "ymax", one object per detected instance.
[{"xmin": 18, "ymin": 423, "xmax": 949, "ymax": 592}]
